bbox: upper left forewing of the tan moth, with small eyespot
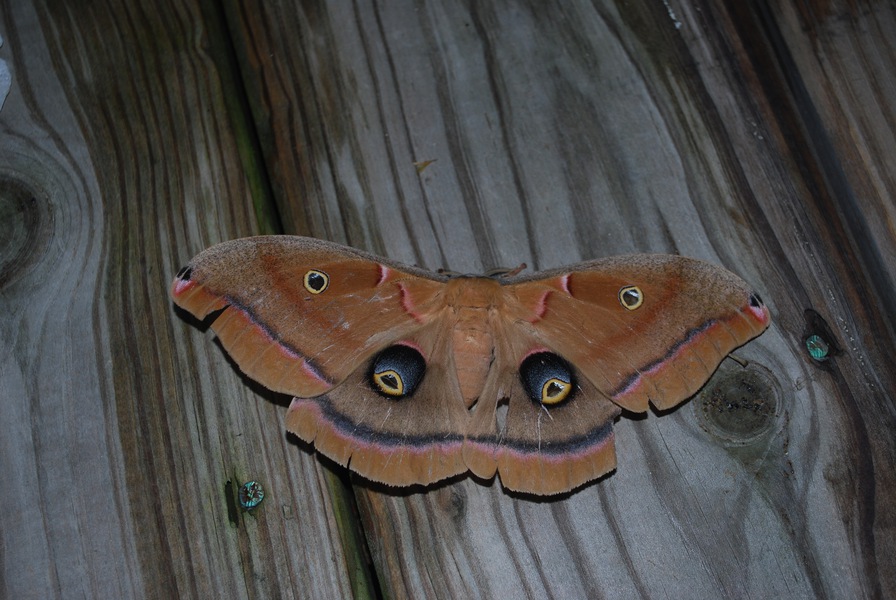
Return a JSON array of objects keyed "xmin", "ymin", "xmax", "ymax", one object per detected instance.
[{"xmin": 171, "ymin": 236, "xmax": 444, "ymax": 397}]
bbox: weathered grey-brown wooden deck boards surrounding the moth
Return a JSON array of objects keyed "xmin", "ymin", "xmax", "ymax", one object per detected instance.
[{"xmin": 0, "ymin": 0, "xmax": 896, "ymax": 598}]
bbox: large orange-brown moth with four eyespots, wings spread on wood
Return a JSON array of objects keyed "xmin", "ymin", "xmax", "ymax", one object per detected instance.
[{"xmin": 171, "ymin": 236, "xmax": 770, "ymax": 494}]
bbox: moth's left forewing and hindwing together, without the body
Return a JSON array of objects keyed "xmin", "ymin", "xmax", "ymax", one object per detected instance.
[{"xmin": 171, "ymin": 236, "xmax": 469, "ymax": 486}]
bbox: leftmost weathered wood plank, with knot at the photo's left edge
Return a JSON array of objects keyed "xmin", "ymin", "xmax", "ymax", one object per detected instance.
[{"xmin": 0, "ymin": 1, "xmax": 351, "ymax": 598}]
